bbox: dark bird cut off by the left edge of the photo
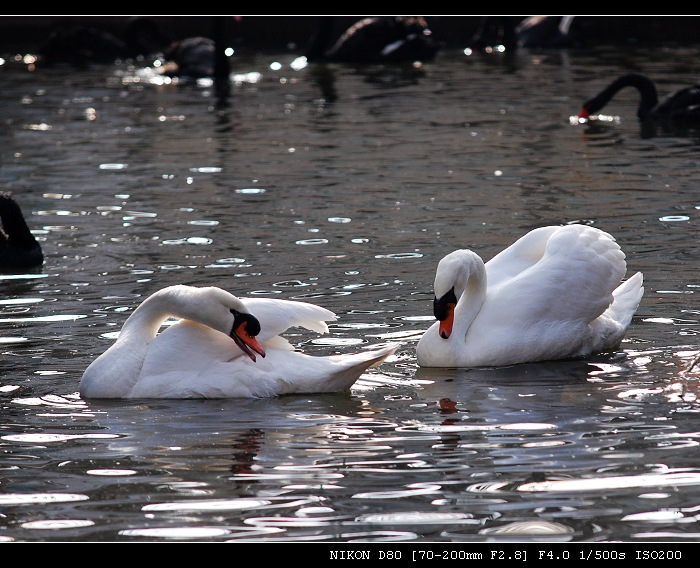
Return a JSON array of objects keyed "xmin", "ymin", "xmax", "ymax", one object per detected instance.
[{"xmin": 0, "ymin": 191, "xmax": 44, "ymax": 270}]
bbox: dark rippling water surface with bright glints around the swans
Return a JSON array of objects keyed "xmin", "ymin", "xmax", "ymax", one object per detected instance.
[{"xmin": 0, "ymin": 41, "xmax": 700, "ymax": 543}]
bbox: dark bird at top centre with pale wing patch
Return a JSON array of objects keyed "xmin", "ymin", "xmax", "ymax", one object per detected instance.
[{"xmin": 304, "ymin": 16, "xmax": 440, "ymax": 64}]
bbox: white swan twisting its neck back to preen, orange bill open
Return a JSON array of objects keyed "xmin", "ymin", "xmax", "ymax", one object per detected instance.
[{"xmin": 80, "ymin": 285, "xmax": 398, "ymax": 398}]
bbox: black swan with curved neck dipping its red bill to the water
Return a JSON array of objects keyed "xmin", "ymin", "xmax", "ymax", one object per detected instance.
[{"xmin": 578, "ymin": 73, "xmax": 700, "ymax": 124}]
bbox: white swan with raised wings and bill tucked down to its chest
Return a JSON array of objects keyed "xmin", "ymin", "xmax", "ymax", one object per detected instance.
[{"xmin": 416, "ymin": 225, "xmax": 644, "ymax": 367}]
